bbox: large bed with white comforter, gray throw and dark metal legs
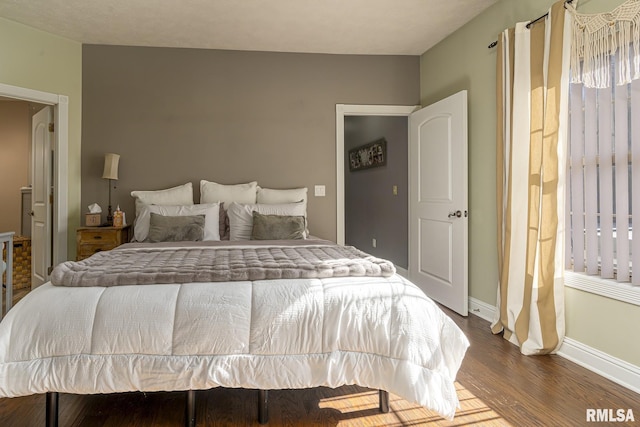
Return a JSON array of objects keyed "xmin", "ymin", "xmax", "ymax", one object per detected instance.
[{"xmin": 0, "ymin": 182, "xmax": 469, "ymax": 425}]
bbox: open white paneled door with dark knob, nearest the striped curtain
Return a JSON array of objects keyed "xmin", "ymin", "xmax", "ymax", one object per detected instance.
[{"xmin": 409, "ymin": 91, "xmax": 469, "ymax": 316}]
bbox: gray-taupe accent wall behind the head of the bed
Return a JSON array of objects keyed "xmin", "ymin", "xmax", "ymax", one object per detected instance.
[{"xmin": 81, "ymin": 45, "xmax": 420, "ymax": 240}]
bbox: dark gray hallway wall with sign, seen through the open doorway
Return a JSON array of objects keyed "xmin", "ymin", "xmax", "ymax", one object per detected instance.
[{"xmin": 344, "ymin": 116, "xmax": 409, "ymax": 269}]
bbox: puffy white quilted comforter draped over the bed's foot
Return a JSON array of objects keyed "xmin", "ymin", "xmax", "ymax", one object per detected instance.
[{"xmin": 0, "ymin": 246, "xmax": 469, "ymax": 418}]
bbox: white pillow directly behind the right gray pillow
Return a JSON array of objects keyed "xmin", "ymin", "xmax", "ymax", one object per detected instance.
[{"xmin": 227, "ymin": 202, "xmax": 306, "ymax": 240}]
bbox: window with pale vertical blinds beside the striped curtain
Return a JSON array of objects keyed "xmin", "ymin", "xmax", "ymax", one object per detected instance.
[{"xmin": 565, "ymin": 57, "xmax": 640, "ymax": 294}]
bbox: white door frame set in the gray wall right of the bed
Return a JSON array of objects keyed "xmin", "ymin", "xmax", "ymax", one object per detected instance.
[{"xmin": 336, "ymin": 104, "xmax": 420, "ymax": 245}]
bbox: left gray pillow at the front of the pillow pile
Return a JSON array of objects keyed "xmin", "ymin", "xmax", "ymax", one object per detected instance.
[{"xmin": 145, "ymin": 212, "xmax": 205, "ymax": 243}]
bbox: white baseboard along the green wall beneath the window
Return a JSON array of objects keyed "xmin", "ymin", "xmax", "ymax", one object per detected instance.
[{"xmin": 469, "ymin": 297, "xmax": 640, "ymax": 393}]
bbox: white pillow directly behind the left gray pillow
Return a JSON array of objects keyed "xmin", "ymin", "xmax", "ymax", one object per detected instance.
[{"xmin": 133, "ymin": 203, "xmax": 220, "ymax": 242}]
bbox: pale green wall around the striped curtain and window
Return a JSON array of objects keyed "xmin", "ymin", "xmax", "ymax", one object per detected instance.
[{"xmin": 420, "ymin": 0, "xmax": 640, "ymax": 366}]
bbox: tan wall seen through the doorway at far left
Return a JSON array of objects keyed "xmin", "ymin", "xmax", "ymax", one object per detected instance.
[{"xmin": 0, "ymin": 101, "xmax": 31, "ymax": 235}]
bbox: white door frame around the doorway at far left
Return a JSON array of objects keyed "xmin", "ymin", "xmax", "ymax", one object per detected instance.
[{"xmin": 0, "ymin": 83, "xmax": 69, "ymax": 265}]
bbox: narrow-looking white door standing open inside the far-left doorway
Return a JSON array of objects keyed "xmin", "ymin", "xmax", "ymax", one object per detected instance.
[{"xmin": 31, "ymin": 107, "xmax": 53, "ymax": 289}]
